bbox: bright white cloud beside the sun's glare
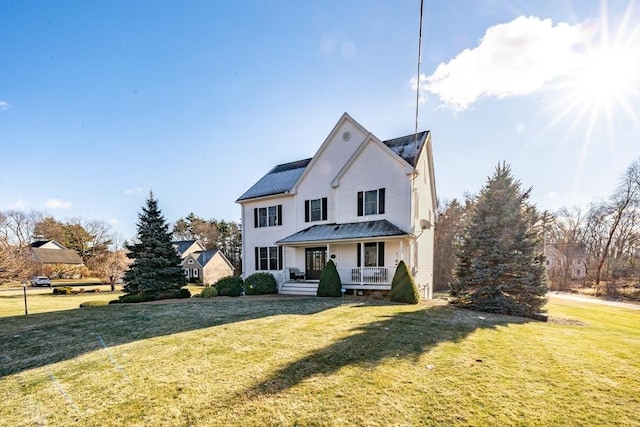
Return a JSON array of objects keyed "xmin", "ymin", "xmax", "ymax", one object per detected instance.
[{"xmin": 411, "ymin": 16, "xmax": 583, "ymax": 111}]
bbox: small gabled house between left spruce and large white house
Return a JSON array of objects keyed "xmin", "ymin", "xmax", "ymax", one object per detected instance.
[{"xmin": 171, "ymin": 240, "xmax": 234, "ymax": 284}]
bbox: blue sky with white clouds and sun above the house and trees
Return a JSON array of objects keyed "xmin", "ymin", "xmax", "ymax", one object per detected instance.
[{"xmin": 0, "ymin": 0, "xmax": 640, "ymax": 238}]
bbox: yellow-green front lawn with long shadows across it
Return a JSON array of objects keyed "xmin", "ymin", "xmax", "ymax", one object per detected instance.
[{"xmin": 0, "ymin": 292, "xmax": 640, "ymax": 426}]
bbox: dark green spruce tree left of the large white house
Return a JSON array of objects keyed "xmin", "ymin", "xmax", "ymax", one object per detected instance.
[{"xmin": 124, "ymin": 192, "xmax": 186, "ymax": 294}]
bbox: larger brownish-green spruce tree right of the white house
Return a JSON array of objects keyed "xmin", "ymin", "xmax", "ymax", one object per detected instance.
[{"xmin": 451, "ymin": 162, "xmax": 548, "ymax": 317}]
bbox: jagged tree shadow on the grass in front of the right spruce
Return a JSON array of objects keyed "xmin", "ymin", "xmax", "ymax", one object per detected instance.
[{"xmin": 242, "ymin": 306, "xmax": 532, "ymax": 398}]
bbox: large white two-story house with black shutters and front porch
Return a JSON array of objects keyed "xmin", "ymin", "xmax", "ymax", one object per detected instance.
[{"xmin": 237, "ymin": 113, "xmax": 436, "ymax": 298}]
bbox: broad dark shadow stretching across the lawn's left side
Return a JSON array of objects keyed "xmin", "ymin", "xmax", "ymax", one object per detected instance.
[{"xmin": 0, "ymin": 297, "xmax": 344, "ymax": 378}]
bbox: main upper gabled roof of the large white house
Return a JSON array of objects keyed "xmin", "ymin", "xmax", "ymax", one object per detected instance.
[{"xmin": 236, "ymin": 113, "xmax": 429, "ymax": 202}]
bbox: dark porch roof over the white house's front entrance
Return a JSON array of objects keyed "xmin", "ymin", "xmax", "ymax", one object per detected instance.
[{"xmin": 276, "ymin": 219, "xmax": 408, "ymax": 244}]
